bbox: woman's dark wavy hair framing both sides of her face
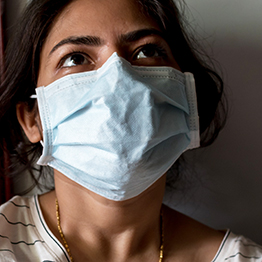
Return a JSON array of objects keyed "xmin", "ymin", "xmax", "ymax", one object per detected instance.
[{"xmin": 0, "ymin": 0, "xmax": 226, "ymax": 190}]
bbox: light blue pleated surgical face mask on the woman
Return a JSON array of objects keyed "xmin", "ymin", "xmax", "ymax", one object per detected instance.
[{"xmin": 34, "ymin": 53, "xmax": 199, "ymax": 201}]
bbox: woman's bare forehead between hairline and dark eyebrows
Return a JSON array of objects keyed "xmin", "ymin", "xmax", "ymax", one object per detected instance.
[{"xmin": 43, "ymin": 0, "xmax": 158, "ymax": 49}]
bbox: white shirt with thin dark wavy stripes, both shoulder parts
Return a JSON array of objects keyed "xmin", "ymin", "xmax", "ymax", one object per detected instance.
[{"xmin": 0, "ymin": 196, "xmax": 262, "ymax": 262}]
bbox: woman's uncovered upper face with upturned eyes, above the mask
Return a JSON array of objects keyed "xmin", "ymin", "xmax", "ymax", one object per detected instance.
[{"xmin": 37, "ymin": 0, "xmax": 179, "ymax": 86}]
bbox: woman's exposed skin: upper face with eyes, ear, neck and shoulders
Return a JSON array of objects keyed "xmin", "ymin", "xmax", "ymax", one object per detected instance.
[{"xmin": 17, "ymin": 0, "xmax": 223, "ymax": 262}]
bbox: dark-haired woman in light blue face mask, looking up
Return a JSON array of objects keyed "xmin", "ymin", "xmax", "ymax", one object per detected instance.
[{"xmin": 0, "ymin": 0, "xmax": 262, "ymax": 262}]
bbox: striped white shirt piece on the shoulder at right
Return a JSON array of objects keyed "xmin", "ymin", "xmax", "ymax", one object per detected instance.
[{"xmin": 212, "ymin": 231, "xmax": 262, "ymax": 262}]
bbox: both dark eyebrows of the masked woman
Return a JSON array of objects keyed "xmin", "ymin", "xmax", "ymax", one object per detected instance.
[{"xmin": 49, "ymin": 28, "xmax": 165, "ymax": 56}]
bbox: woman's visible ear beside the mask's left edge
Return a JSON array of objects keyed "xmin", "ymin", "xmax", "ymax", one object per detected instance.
[{"xmin": 16, "ymin": 103, "xmax": 42, "ymax": 143}]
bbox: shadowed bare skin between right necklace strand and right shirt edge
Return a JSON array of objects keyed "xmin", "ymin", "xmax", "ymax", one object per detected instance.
[{"xmin": 166, "ymin": 209, "xmax": 225, "ymax": 262}]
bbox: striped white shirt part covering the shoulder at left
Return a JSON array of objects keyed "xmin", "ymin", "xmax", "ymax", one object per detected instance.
[{"xmin": 0, "ymin": 193, "xmax": 69, "ymax": 262}]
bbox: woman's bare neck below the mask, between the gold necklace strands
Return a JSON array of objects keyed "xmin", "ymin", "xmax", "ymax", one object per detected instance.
[{"xmin": 52, "ymin": 172, "xmax": 165, "ymax": 261}]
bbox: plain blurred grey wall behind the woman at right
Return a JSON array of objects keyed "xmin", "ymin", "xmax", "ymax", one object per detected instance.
[{"xmin": 167, "ymin": 0, "xmax": 262, "ymax": 244}]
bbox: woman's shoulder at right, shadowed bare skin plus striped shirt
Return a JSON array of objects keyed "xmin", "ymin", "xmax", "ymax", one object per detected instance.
[{"xmin": 163, "ymin": 207, "xmax": 262, "ymax": 262}]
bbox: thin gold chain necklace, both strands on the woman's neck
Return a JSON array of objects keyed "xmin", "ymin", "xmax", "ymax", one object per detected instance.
[{"xmin": 55, "ymin": 198, "xmax": 164, "ymax": 262}]
